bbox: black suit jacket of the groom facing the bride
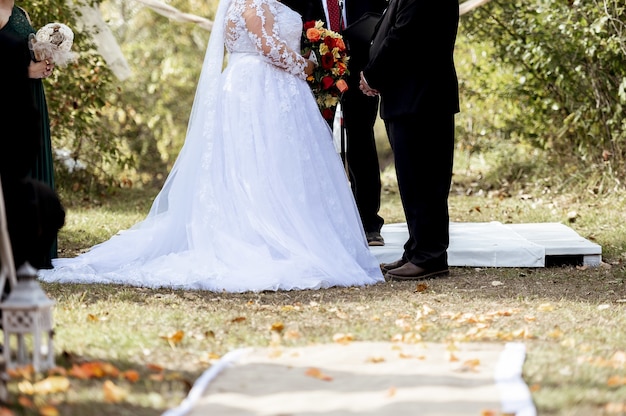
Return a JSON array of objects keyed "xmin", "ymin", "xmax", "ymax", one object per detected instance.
[{"xmin": 363, "ymin": 0, "xmax": 459, "ymax": 119}]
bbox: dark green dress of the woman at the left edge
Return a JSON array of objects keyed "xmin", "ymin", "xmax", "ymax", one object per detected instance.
[{"xmin": 0, "ymin": 6, "xmax": 57, "ymax": 267}]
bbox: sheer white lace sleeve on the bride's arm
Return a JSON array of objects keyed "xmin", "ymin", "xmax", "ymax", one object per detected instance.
[{"xmin": 235, "ymin": 0, "xmax": 306, "ymax": 79}]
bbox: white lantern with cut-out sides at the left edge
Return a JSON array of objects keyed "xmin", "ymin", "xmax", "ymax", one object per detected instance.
[{"xmin": 0, "ymin": 263, "xmax": 55, "ymax": 372}]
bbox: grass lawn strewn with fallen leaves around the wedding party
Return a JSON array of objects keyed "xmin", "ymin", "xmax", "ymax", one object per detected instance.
[{"xmin": 1, "ymin": 162, "xmax": 626, "ymax": 416}]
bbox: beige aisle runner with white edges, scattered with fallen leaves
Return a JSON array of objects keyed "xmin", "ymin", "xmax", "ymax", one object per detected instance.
[{"xmin": 163, "ymin": 342, "xmax": 536, "ymax": 416}]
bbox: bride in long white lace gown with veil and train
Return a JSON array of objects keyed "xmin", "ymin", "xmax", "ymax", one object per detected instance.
[{"xmin": 39, "ymin": 0, "xmax": 384, "ymax": 292}]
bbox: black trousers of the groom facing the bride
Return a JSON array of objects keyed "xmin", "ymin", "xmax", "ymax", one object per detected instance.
[{"xmin": 385, "ymin": 111, "xmax": 454, "ymax": 270}]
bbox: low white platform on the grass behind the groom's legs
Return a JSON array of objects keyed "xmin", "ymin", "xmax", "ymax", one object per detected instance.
[{"xmin": 370, "ymin": 221, "xmax": 602, "ymax": 267}]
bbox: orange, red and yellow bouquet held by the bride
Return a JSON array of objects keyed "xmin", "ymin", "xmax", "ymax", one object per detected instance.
[{"xmin": 302, "ymin": 20, "xmax": 350, "ymax": 120}]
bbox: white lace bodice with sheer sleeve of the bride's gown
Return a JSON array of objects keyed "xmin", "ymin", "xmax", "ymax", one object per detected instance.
[{"xmin": 224, "ymin": 0, "xmax": 306, "ymax": 79}]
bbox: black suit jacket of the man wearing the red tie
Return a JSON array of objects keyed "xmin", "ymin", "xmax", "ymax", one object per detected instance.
[{"xmin": 281, "ymin": 0, "xmax": 387, "ymax": 69}]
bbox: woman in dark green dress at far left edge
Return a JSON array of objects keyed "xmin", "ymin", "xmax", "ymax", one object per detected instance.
[{"xmin": 0, "ymin": 0, "xmax": 57, "ymax": 268}]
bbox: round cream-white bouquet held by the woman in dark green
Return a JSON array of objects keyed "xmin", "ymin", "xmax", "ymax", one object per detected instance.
[{"xmin": 29, "ymin": 23, "xmax": 77, "ymax": 66}]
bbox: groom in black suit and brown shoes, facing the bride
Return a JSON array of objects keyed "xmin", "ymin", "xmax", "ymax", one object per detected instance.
[{"xmin": 361, "ymin": 0, "xmax": 459, "ymax": 280}]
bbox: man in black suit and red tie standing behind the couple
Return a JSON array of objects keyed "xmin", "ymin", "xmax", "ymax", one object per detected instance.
[{"xmin": 282, "ymin": 0, "xmax": 387, "ymax": 246}]
